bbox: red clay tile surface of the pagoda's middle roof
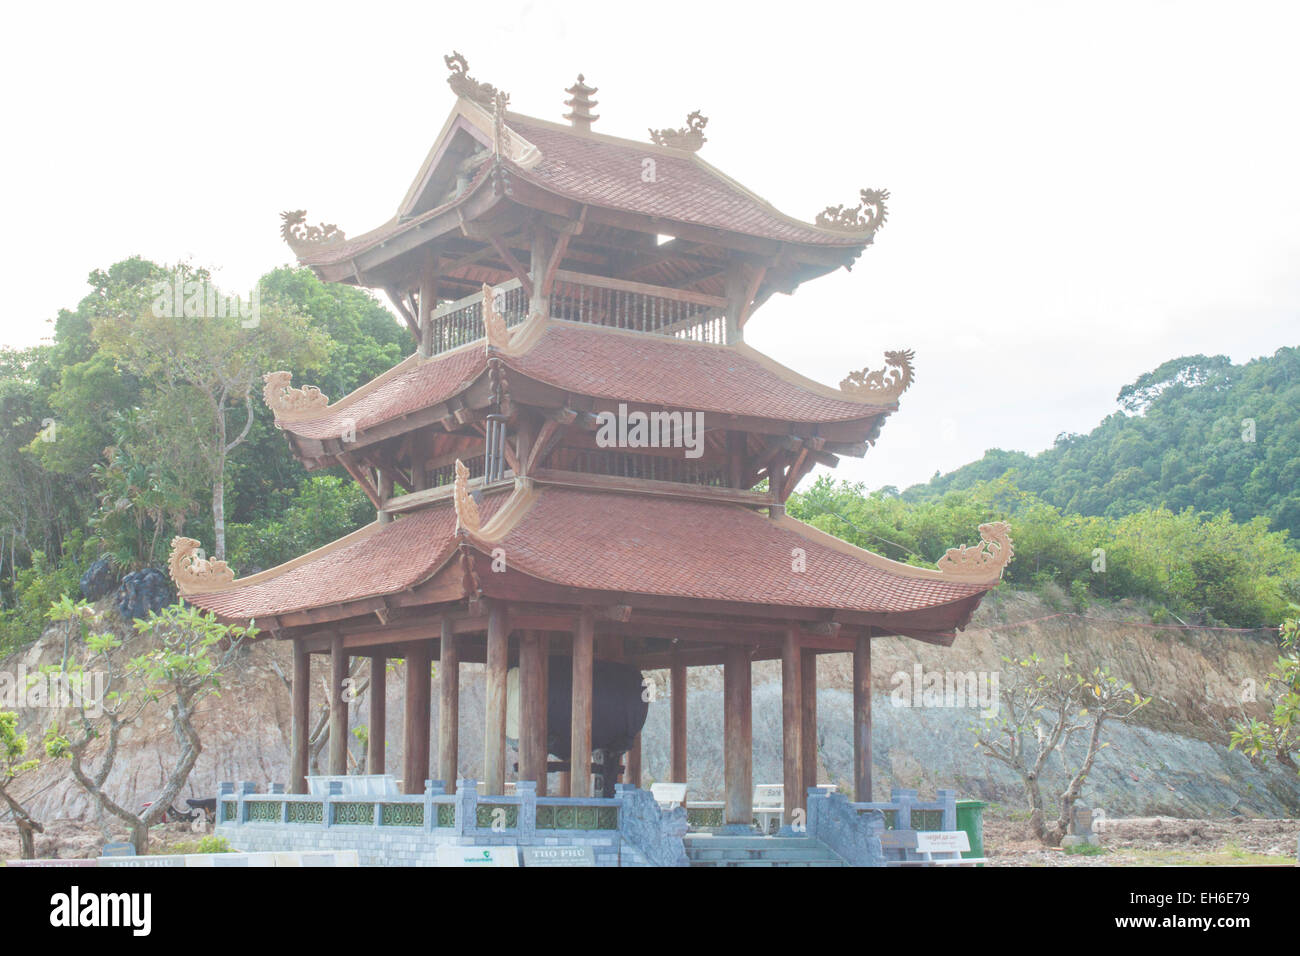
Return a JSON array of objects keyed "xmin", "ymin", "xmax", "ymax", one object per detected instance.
[{"xmin": 281, "ymin": 320, "xmax": 885, "ymax": 440}]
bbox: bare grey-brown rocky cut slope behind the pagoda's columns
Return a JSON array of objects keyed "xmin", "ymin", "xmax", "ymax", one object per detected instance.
[{"xmin": 0, "ymin": 592, "xmax": 1300, "ymax": 819}]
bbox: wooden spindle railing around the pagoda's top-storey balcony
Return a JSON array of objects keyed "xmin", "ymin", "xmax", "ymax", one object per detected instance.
[{"xmin": 433, "ymin": 271, "xmax": 727, "ymax": 354}]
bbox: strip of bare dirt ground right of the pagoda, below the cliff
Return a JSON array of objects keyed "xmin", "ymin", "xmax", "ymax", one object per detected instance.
[{"xmin": 984, "ymin": 817, "xmax": 1300, "ymax": 866}]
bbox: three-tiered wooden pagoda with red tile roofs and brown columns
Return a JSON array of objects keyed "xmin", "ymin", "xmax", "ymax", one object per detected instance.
[{"xmin": 172, "ymin": 53, "xmax": 1011, "ymax": 826}]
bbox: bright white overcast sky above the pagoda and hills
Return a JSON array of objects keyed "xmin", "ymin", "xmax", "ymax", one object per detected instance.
[{"xmin": 0, "ymin": 0, "xmax": 1300, "ymax": 486}]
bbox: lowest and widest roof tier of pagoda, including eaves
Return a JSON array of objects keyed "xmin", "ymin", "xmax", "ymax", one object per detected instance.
[{"xmin": 173, "ymin": 481, "xmax": 1001, "ymax": 635}]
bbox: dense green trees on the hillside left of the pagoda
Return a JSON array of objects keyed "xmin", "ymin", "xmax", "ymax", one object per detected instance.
[{"xmin": 0, "ymin": 258, "xmax": 410, "ymax": 653}]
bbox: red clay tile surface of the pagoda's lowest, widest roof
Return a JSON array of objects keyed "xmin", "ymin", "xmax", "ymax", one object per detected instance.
[{"xmin": 187, "ymin": 488, "xmax": 992, "ymax": 626}]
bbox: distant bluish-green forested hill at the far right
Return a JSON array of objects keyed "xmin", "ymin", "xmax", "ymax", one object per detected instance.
[{"xmin": 904, "ymin": 347, "xmax": 1300, "ymax": 538}]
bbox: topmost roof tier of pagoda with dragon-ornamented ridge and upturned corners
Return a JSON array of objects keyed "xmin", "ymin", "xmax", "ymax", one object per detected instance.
[{"xmin": 282, "ymin": 57, "xmax": 888, "ymax": 297}]
